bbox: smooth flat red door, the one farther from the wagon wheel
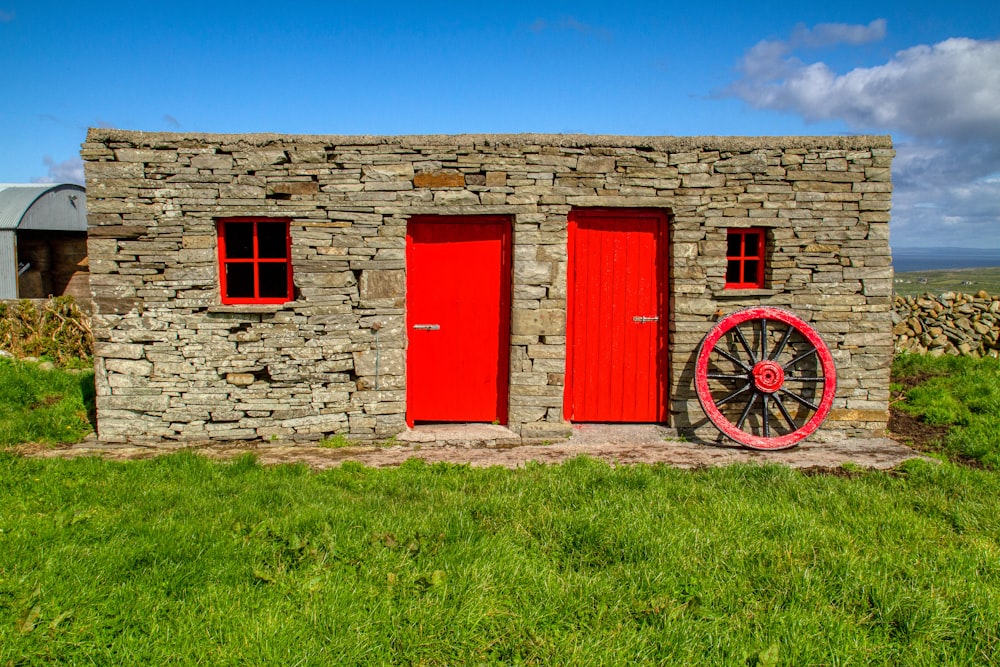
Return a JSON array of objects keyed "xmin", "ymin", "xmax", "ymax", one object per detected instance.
[{"xmin": 406, "ymin": 216, "xmax": 510, "ymax": 425}]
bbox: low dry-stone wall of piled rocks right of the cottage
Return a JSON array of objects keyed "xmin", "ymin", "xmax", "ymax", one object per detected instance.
[{"xmin": 892, "ymin": 291, "xmax": 1000, "ymax": 357}]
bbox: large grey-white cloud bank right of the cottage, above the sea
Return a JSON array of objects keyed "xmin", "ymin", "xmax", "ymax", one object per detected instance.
[{"xmin": 727, "ymin": 20, "xmax": 1000, "ymax": 247}]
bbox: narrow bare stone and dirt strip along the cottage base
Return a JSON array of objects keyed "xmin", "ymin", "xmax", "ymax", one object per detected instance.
[{"xmin": 21, "ymin": 425, "xmax": 919, "ymax": 470}]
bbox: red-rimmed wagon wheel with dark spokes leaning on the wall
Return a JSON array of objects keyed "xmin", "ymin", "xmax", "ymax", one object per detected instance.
[{"xmin": 695, "ymin": 307, "xmax": 837, "ymax": 449}]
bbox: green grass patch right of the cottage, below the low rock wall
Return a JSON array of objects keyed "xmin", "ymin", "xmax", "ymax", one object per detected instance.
[{"xmin": 893, "ymin": 355, "xmax": 1000, "ymax": 470}]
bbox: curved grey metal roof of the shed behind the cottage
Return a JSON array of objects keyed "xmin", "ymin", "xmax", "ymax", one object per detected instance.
[{"xmin": 0, "ymin": 183, "xmax": 87, "ymax": 232}]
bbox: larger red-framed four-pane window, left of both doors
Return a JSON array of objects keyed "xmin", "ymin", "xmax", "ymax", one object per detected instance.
[{"xmin": 218, "ymin": 218, "xmax": 292, "ymax": 303}]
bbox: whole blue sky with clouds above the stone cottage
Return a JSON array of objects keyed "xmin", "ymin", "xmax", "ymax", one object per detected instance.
[{"xmin": 0, "ymin": 0, "xmax": 1000, "ymax": 248}]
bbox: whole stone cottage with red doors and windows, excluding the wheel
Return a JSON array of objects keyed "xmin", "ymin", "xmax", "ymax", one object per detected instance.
[{"xmin": 82, "ymin": 129, "xmax": 894, "ymax": 442}]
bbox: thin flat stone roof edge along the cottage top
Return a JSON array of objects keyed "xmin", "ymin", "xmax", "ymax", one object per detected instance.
[{"xmin": 87, "ymin": 128, "xmax": 892, "ymax": 151}]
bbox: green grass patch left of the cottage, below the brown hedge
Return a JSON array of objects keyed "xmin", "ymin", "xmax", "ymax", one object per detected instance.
[{"xmin": 0, "ymin": 359, "xmax": 94, "ymax": 446}]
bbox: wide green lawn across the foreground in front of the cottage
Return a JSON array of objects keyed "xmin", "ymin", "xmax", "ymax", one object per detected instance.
[{"xmin": 0, "ymin": 453, "xmax": 1000, "ymax": 665}]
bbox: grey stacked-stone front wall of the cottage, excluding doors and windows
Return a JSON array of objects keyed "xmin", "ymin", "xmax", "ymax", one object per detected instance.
[{"xmin": 82, "ymin": 129, "xmax": 894, "ymax": 442}]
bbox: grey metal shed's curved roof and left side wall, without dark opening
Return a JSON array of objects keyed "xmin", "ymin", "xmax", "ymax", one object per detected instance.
[{"xmin": 0, "ymin": 183, "xmax": 87, "ymax": 299}]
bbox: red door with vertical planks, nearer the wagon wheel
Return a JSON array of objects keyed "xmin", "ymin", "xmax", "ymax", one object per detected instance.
[{"xmin": 564, "ymin": 209, "xmax": 668, "ymax": 422}]
